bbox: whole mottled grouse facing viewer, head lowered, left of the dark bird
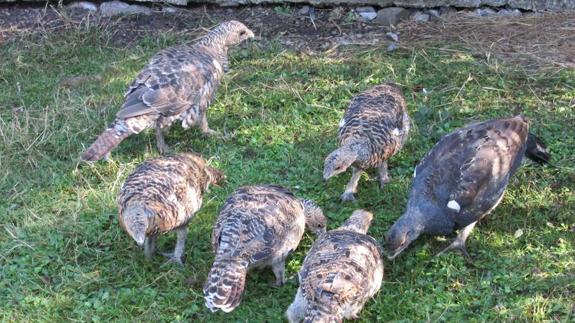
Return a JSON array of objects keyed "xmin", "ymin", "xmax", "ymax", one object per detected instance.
[{"xmin": 323, "ymin": 84, "xmax": 410, "ymax": 201}]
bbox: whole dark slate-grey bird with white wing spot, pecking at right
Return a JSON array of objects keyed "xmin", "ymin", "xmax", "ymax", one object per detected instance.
[{"xmin": 385, "ymin": 116, "xmax": 550, "ymax": 259}]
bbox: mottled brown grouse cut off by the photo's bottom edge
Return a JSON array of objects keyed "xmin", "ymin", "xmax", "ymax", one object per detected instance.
[{"xmin": 286, "ymin": 210, "xmax": 383, "ymax": 323}]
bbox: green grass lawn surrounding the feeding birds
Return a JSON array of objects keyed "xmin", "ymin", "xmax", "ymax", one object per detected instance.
[{"xmin": 0, "ymin": 26, "xmax": 575, "ymax": 322}]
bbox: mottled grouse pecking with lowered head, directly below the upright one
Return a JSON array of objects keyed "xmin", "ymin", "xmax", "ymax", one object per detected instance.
[{"xmin": 118, "ymin": 153, "xmax": 224, "ymax": 264}]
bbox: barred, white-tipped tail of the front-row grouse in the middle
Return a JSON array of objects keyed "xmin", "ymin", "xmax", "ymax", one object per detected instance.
[{"xmin": 204, "ymin": 259, "xmax": 248, "ymax": 313}]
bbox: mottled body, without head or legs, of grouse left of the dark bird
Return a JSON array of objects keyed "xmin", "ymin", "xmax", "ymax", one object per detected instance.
[{"xmin": 338, "ymin": 84, "xmax": 409, "ymax": 169}]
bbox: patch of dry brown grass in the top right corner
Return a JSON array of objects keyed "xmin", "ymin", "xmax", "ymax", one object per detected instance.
[{"xmin": 402, "ymin": 13, "xmax": 575, "ymax": 72}]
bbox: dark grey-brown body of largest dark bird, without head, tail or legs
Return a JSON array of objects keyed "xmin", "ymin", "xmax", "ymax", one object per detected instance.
[{"xmin": 409, "ymin": 116, "xmax": 529, "ymax": 227}]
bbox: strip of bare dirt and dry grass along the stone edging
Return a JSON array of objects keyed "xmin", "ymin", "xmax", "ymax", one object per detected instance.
[{"xmin": 0, "ymin": 6, "xmax": 575, "ymax": 71}]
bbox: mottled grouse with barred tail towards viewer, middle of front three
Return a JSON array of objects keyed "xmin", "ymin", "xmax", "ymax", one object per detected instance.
[{"xmin": 204, "ymin": 185, "xmax": 326, "ymax": 313}]
